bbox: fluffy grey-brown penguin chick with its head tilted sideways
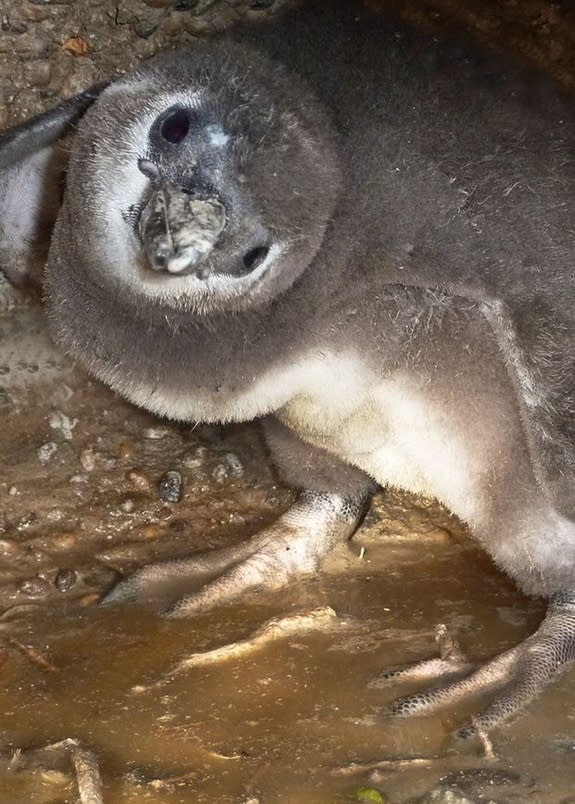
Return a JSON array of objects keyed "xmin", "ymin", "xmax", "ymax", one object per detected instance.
[{"xmin": 3, "ymin": 2, "xmax": 575, "ymax": 730}]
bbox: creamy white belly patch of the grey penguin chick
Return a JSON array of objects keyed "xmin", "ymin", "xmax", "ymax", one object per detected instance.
[{"xmin": 280, "ymin": 352, "xmax": 481, "ymax": 523}]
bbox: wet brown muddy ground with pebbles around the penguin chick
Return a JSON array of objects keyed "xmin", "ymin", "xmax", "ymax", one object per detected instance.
[{"xmin": 0, "ymin": 0, "xmax": 575, "ymax": 804}]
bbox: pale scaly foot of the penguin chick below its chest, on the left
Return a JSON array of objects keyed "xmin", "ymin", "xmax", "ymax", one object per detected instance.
[{"xmin": 102, "ymin": 491, "xmax": 366, "ymax": 617}]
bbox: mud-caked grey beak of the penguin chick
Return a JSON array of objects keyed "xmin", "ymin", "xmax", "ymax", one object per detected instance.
[{"xmin": 138, "ymin": 159, "xmax": 226, "ymax": 278}]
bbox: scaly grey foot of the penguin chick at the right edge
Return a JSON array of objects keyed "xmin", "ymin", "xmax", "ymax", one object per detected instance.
[{"xmin": 377, "ymin": 593, "xmax": 575, "ymax": 739}]
